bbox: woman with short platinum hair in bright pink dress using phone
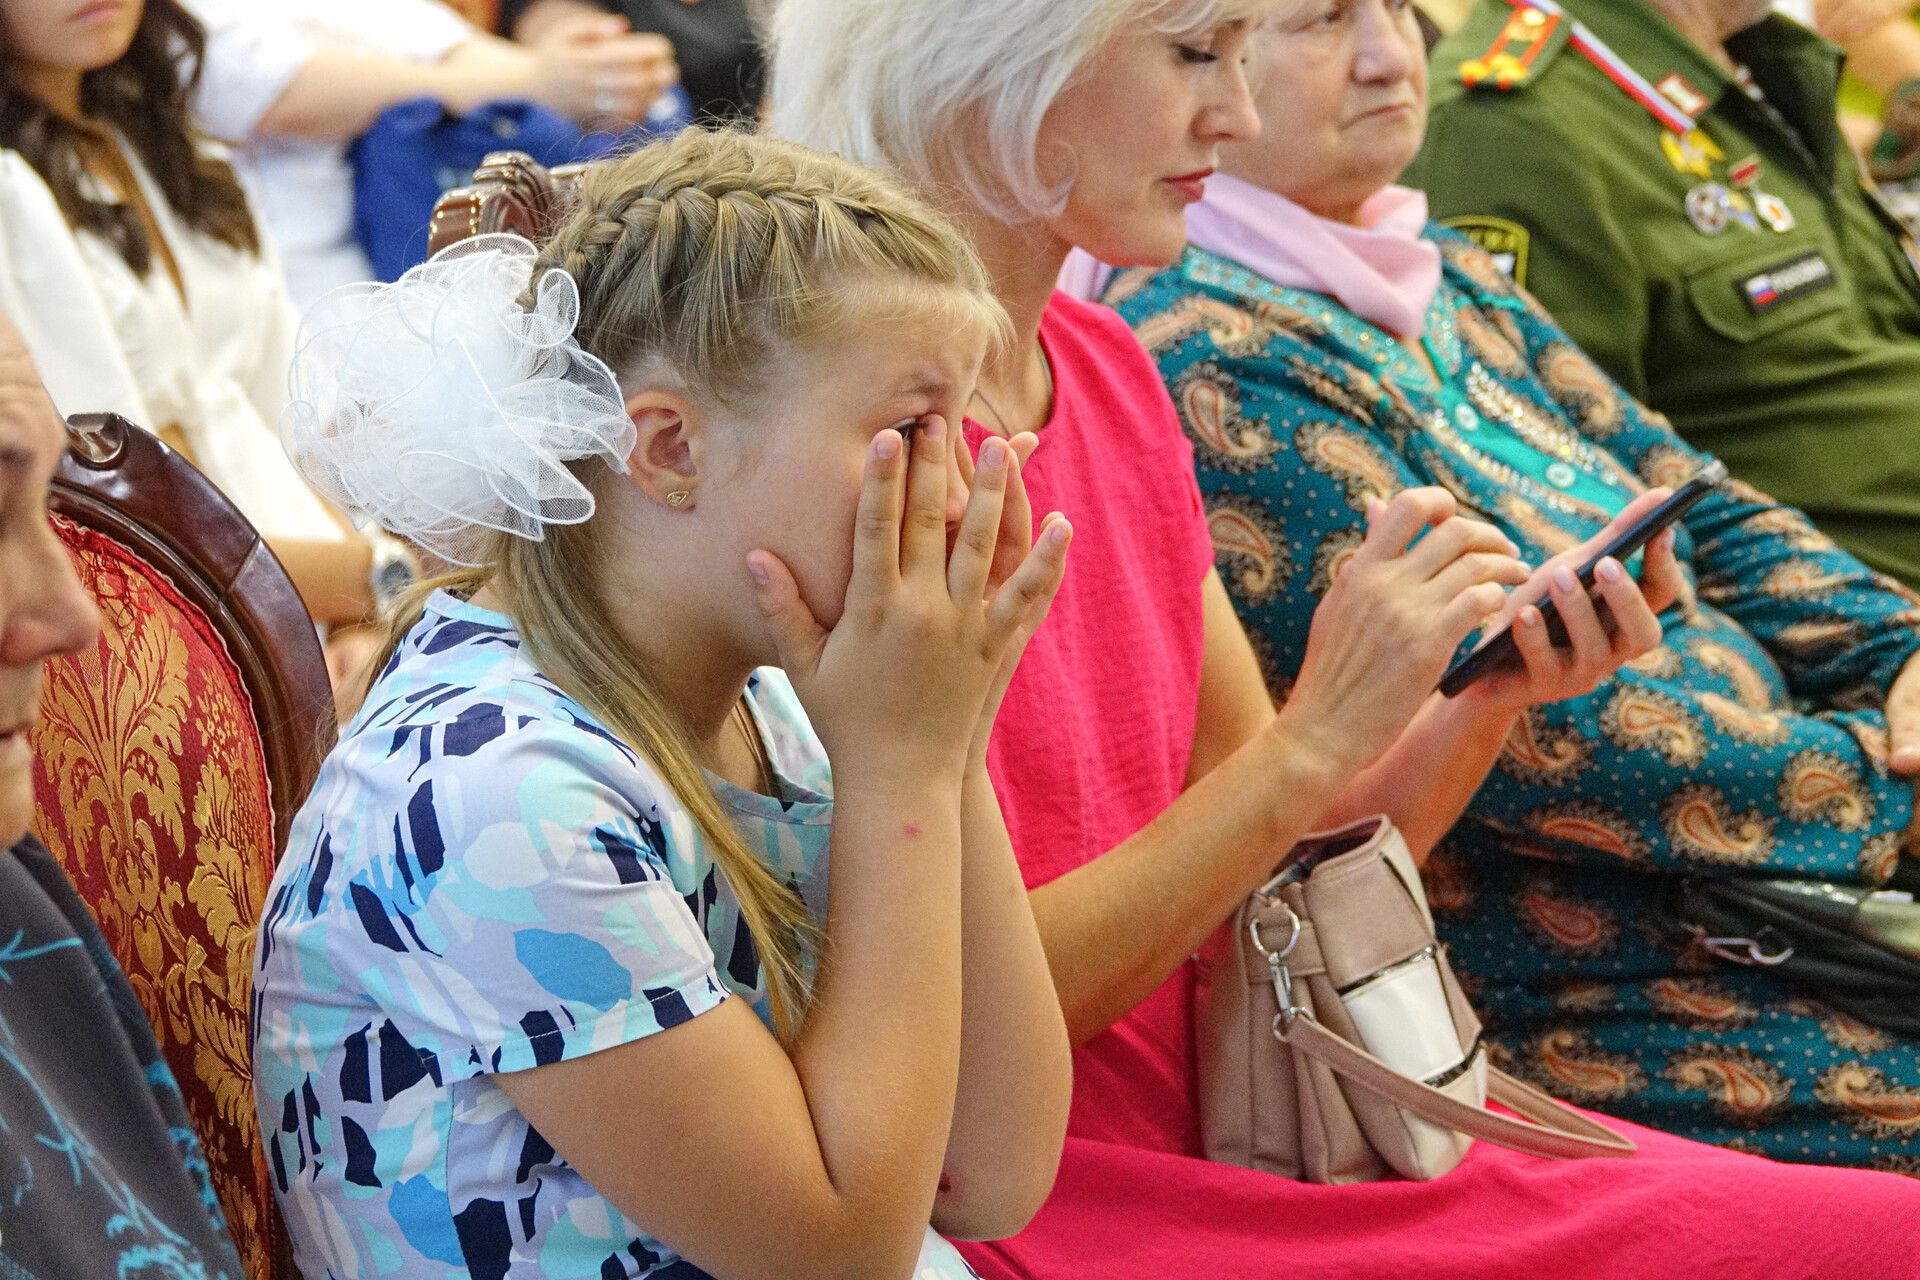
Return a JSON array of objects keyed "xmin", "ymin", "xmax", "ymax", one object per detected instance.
[{"xmin": 774, "ymin": 0, "xmax": 1920, "ymax": 1280}]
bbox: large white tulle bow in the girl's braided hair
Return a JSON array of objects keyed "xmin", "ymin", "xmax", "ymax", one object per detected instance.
[{"xmin": 280, "ymin": 234, "xmax": 634, "ymax": 566}]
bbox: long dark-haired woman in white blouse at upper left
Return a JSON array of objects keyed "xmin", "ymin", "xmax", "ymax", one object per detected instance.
[{"xmin": 0, "ymin": 0, "xmax": 397, "ymax": 679}]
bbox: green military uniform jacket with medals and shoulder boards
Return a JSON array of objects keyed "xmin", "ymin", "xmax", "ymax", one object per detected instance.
[{"xmin": 1404, "ymin": 0, "xmax": 1920, "ymax": 585}]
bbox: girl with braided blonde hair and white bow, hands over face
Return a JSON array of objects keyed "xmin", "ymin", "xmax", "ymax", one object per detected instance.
[{"xmin": 255, "ymin": 130, "xmax": 1069, "ymax": 1280}]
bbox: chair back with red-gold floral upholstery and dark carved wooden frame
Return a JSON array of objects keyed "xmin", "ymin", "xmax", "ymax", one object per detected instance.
[{"xmin": 35, "ymin": 418, "xmax": 332, "ymax": 1280}]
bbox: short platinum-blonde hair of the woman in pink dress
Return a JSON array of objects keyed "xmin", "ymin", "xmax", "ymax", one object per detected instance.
[{"xmin": 768, "ymin": 0, "xmax": 1271, "ymax": 225}]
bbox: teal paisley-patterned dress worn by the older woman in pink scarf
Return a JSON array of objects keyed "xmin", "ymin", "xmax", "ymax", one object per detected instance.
[{"xmin": 1106, "ymin": 226, "xmax": 1920, "ymax": 1174}]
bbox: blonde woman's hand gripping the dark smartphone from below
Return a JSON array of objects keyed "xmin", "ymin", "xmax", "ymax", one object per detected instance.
[{"xmin": 1459, "ymin": 489, "xmax": 1686, "ymax": 710}]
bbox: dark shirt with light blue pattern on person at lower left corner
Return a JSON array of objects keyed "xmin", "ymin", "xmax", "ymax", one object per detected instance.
[{"xmin": 0, "ymin": 837, "xmax": 242, "ymax": 1280}]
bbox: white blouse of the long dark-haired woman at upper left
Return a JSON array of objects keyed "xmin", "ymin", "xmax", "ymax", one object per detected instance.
[{"xmin": 0, "ymin": 146, "xmax": 348, "ymax": 541}]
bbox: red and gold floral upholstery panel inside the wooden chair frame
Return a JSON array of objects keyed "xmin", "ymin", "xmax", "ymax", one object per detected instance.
[{"xmin": 33, "ymin": 516, "xmax": 273, "ymax": 1276}]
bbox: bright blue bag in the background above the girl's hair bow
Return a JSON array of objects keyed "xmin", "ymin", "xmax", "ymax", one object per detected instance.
[{"xmin": 348, "ymin": 84, "xmax": 693, "ymax": 280}]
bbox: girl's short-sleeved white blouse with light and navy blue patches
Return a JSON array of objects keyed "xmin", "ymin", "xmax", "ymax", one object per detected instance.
[{"xmin": 253, "ymin": 593, "xmax": 972, "ymax": 1280}]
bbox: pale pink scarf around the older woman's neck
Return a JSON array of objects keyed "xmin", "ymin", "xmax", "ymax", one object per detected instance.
[{"xmin": 1060, "ymin": 173, "xmax": 1440, "ymax": 338}]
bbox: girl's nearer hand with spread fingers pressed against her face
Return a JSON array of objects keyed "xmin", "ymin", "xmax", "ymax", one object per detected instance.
[{"xmin": 747, "ymin": 415, "xmax": 1071, "ymax": 781}]
